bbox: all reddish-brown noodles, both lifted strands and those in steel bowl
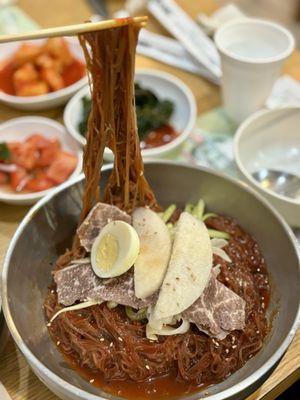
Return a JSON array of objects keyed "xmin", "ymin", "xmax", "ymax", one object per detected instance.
[{"xmin": 44, "ymin": 20, "xmax": 270, "ymax": 398}]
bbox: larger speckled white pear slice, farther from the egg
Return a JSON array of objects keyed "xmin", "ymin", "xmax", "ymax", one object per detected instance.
[{"xmin": 154, "ymin": 212, "xmax": 213, "ymax": 319}]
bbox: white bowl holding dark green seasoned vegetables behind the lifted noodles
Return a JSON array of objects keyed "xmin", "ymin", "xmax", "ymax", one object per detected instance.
[{"xmin": 64, "ymin": 69, "xmax": 197, "ymax": 161}]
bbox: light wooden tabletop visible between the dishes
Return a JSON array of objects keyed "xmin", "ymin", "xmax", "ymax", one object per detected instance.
[{"xmin": 0, "ymin": 0, "xmax": 300, "ymax": 400}]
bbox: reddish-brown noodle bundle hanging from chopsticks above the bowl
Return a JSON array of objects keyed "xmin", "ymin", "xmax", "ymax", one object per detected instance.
[{"xmin": 79, "ymin": 24, "xmax": 157, "ymax": 221}]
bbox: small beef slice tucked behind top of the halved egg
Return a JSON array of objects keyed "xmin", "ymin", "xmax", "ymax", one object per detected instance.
[{"xmin": 77, "ymin": 203, "xmax": 131, "ymax": 251}]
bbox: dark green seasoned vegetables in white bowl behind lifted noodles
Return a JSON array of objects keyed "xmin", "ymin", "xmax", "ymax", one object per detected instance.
[{"xmin": 78, "ymin": 83, "xmax": 174, "ymax": 140}]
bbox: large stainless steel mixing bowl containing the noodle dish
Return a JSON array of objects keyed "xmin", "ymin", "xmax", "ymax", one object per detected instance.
[{"xmin": 2, "ymin": 162, "xmax": 300, "ymax": 400}]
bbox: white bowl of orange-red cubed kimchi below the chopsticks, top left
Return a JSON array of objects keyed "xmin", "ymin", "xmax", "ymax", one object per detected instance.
[{"xmin": 0, "ymin": 38, "xmax": 88, "ymax": 110}]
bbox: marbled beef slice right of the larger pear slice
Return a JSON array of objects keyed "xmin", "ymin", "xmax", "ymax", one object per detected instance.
[{"xmin": 183, "ymin": 270, "xmax": 246, "ymax": 340}]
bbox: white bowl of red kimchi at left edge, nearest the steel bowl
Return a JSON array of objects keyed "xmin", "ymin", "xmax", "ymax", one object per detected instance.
[{"xmin": 0, "ymin": 117, "xmax": 82, "ymax": 205}]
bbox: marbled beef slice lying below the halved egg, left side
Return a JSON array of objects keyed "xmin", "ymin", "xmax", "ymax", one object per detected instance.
[{"xmin": 54, "ymin": 264, "xmax": 155, "ymax": 309}]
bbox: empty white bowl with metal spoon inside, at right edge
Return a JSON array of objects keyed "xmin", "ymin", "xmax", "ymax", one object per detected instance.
[{"xmin": 234, "ymin": 107, "xmax": 300, "ymax": 227}]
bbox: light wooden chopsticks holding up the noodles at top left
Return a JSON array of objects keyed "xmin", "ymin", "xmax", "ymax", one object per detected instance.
[{"xmin": 0, "ymin": 17, "xmax": 148, "ymax": 43}]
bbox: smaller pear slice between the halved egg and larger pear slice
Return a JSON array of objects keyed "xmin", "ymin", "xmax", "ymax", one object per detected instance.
[{"xmin": 132, "ymin": 207, "xmax": 172, "ymax": 299}]
